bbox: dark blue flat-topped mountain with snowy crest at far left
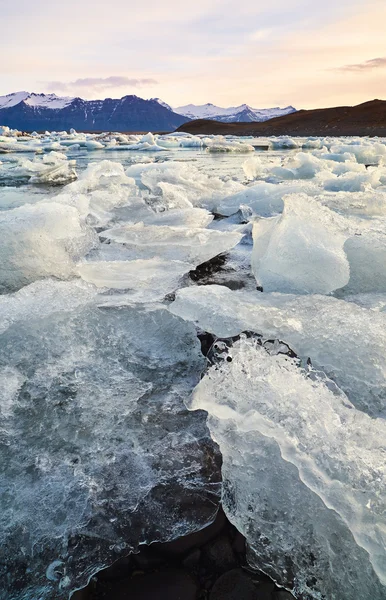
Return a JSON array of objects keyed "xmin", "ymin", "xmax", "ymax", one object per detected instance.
[{"xmin": 0, "ymin": 92, "xmax": 187, "ymax": 132}]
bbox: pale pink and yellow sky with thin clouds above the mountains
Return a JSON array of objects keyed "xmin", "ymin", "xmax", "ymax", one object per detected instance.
[{"xmin": 0, "ymin": 0, "xmax": 386, "ymax": 109}]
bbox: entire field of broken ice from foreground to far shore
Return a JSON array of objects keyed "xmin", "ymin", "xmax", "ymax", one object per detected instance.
[{"xmin": 0, "ymin": 132, "xmax": 386, "ymax": 600}]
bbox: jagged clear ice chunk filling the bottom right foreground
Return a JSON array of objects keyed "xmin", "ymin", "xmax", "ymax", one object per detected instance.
[{"xmin": 190, "ymin": 336, "xmax": 386, "ymax": 600}]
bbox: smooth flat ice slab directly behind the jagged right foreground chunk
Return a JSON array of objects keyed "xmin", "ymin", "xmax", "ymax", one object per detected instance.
[{"xmin": 170, "ymin": 285, "xmax": 386, "ymax": 417}]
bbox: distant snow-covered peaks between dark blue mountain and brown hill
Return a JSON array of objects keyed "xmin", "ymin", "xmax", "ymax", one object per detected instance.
[{"xmin": 174, "ymin": 103, "xmax": 296, "ymax": 123}]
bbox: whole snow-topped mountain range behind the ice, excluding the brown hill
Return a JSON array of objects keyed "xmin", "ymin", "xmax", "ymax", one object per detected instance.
[{"xmin": 0, "ymin": 92, "xmax": 295, "ymax": 132}]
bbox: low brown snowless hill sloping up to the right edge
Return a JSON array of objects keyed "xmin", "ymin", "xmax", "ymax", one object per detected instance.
[{"xmin": 178, "ymin": 100, "xmax": 386, "ymax": 136}]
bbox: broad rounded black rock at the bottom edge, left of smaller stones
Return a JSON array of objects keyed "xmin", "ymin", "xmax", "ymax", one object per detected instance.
[{"xmin": 105, "ymin": 569, "xmax": 198, "ymax": 600}]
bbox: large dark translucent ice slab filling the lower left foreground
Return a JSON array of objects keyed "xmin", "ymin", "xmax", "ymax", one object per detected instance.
[{"xmin": 0, "ymin": 282, "xmax": 219, "ymax": 600}]
